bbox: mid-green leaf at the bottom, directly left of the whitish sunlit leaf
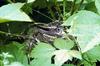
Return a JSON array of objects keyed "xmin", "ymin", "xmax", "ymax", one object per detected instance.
[{"xmin": 31, "ymin": 43, "xmax": 55, "ymax": 66}]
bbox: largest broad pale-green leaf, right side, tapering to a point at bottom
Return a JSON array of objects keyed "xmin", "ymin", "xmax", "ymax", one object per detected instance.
[{"xmin": 64, "ymin": 10, "xmax": 100, "ymax": 52}]
